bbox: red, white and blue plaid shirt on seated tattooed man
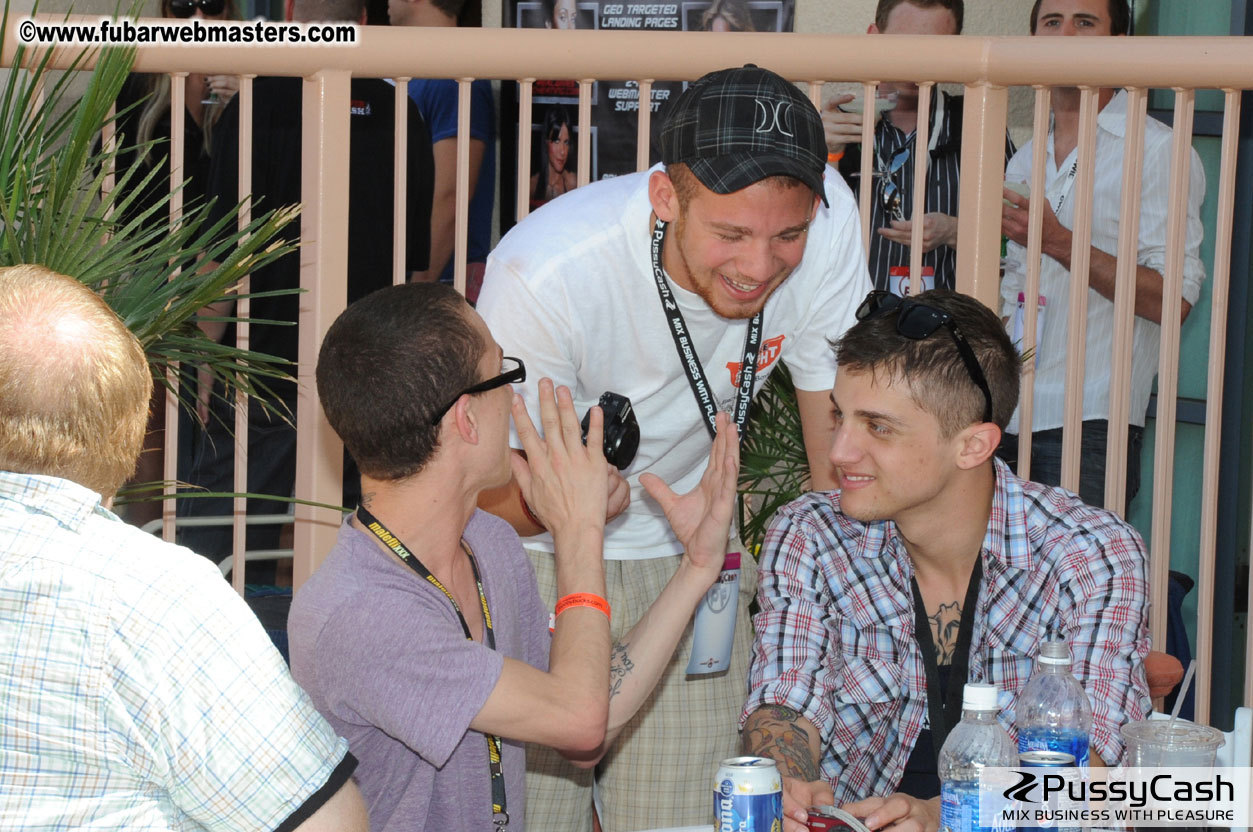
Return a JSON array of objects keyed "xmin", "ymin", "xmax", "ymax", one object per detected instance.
[{"xmin": 741, "ymin": 460, "xmax": 1150, "ymax": 804}]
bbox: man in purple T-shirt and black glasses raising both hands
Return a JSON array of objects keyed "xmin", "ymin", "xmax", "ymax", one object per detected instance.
[{"xmin": 288, "ymin": 283, "xmax": 739, "ymax": 832}]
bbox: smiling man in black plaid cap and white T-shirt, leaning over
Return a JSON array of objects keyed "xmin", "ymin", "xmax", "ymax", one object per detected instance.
[{"xmin": 479, "ymin": 66, "xmax": 870, "ymax": 832}]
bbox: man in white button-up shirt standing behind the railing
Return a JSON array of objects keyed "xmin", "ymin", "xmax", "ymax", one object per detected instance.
[{"xmin": 1001, "ymin": 0, "xmax": 1205, "ymax": 510}]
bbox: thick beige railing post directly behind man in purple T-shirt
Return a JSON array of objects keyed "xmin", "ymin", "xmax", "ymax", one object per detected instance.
[{"xmin": 293, "ymin": 70, "xmax": 351, "ymax": 586}]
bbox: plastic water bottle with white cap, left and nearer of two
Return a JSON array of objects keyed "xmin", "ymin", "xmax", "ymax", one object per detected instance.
[{"xmin": 940, "ymin": 683, "xmax": 1017, "ymax": 832}]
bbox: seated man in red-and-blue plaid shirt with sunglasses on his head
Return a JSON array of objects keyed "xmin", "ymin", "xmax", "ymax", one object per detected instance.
[{"xmin": 744, "ymin": 289, "xmax": 1150, "ymax": 832}]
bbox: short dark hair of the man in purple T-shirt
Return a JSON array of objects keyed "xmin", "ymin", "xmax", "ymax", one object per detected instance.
[{"xmin": 317, "ymin": 283, "xmax": 486, "ymax": 480}]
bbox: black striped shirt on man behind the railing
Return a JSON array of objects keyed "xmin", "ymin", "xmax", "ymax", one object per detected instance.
[{"xmin": 840, "ymin": 91, "xmax": 1014, "ymax": 293}]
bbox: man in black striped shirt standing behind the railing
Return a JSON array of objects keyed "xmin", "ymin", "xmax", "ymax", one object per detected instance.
[{"xmin": 822, "ymin": 0, "xmax": 1014, "ymax": 294}]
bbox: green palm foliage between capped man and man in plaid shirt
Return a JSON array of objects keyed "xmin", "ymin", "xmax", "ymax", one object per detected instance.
[{"xmin": 739, "ymin": 365, "xmax": 809, "ymax": 553}]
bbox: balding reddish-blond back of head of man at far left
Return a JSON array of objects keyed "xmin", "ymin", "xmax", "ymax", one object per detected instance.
[{"xmin": 0, "ymin": 266, "xmax": 153, "ymax": 497}]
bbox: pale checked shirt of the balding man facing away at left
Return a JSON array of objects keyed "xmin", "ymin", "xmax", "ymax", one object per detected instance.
[{"xmin": 0, "ymin": 471, "xmax": 351, "ymax": 832}]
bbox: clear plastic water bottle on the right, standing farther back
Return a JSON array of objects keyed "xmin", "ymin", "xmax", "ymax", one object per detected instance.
[{"xmin": 1016, "ymin": 642, "xmax": 1093, "ymax": 768}]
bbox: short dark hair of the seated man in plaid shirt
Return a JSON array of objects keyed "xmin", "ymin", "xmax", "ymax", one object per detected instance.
[{"xmin": 834, "ymin": 289, "xmax": 1022, "ymax": 439}]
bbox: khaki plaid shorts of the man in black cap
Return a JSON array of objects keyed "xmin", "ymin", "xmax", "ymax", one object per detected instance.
[{"xmin": 526, "ymin": 543, "xmax": 757, "ymax": 832}]
